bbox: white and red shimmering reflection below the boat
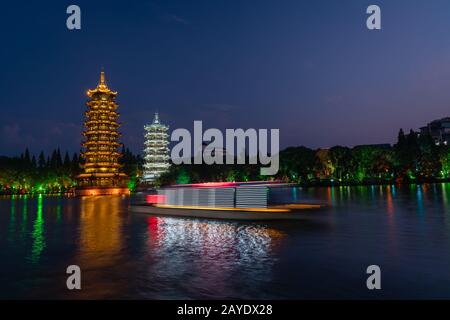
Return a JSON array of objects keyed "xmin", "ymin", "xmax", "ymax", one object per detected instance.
[{"xmin": 147, "ymin": 217, "xmax": 285, "ymax": 298}]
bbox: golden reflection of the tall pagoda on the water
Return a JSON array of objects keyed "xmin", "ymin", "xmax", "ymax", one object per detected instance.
[{"xmin": 74, "ymin": 196, "xmax": 125, "ymax": 299}]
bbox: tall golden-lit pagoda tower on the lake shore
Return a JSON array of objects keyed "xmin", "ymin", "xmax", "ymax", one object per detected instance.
[{"xmin": 76, "ymin": 70, "xmax": 129, "ymax": 195}]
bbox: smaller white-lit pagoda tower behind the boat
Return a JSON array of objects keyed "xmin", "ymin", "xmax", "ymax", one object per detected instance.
[{"xmin": 143, "ymin": 113, "xmax": 170, "ymax": 183}]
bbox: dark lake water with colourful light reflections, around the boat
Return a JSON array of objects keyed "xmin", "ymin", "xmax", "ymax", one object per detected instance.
[{"xmin": 0, "ymin": 184, "xmax": 450, "ymax": 299}]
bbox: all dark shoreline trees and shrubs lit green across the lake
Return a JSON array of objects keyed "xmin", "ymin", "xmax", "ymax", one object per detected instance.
[{"xmin": 0, "ymin": 130, "xmax": 450, "ymax": 195}]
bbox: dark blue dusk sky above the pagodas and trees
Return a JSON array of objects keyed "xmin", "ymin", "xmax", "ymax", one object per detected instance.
[{"xmin": 0, "ymin": 0, "xmax": 450, "ymax": 155}]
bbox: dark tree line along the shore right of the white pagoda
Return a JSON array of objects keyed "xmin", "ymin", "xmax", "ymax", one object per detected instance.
[{"xmin": 157, "ymin": 129, "xmax": 450, "ymax": 186}]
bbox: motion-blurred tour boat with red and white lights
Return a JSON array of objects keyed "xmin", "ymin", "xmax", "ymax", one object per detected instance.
[{"xmin": 131, "ymin": 181, "xmax": 325, "ymax": 221}]
